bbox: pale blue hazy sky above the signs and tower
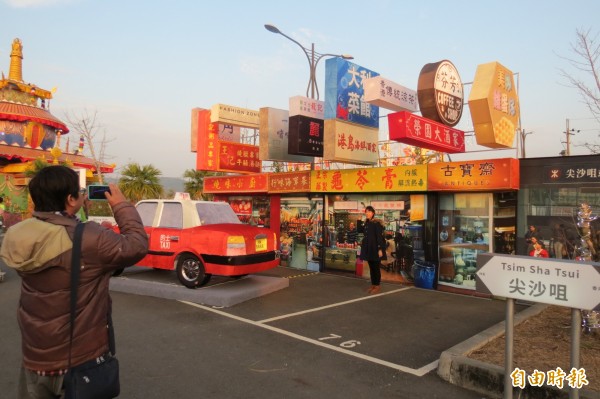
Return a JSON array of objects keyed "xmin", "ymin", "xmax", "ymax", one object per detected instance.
[{"xmin": 0, "ymin": 0, "xmax": 600, "ymax": 177}]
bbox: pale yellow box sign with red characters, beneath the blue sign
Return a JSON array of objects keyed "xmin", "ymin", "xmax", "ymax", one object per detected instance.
[{"xmin": 323, "ymin": 119, "xmax": 379, "ymax": 165}]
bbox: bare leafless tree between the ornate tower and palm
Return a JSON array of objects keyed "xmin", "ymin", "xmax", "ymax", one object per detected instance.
[{"xmin": 65, "ymin": 110, "xmax": 112, "ymax": 184}]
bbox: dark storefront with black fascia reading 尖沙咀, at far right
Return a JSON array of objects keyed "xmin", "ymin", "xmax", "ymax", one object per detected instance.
[{"xmin": 516, "ymin": 155, "xmax": 600, "ymax": 261}]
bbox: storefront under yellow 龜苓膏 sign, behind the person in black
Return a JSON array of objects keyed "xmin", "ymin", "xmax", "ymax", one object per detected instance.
[{"xmin": 311, "ymin": 165, "xmax": 427, "ymax": 282}]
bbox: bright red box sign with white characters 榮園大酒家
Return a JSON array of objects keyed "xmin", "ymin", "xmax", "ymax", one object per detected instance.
[{"xmin": 388, "ymin": 111, "xmax": 465, "ymax": 154}]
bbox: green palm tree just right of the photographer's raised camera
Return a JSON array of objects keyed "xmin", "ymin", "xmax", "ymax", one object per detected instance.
[{"xmin": 119, "ymin": 163, "xmax": 164, "ymax": 203}]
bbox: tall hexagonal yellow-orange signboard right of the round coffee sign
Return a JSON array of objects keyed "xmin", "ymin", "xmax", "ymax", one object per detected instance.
[{"xmin": 469, "ymin": 62, "xmax": 519, "ymax": 148}]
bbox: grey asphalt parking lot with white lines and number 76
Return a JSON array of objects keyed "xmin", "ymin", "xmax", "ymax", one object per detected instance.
[{"xmin": 0, "ymin": 264, "xmax": 552, "ymax": 399}]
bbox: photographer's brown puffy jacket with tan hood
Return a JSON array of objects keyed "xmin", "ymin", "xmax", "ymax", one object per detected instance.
[{"xmin": 0, "ymin": 202, "xmax": 148, "ymax": 371}]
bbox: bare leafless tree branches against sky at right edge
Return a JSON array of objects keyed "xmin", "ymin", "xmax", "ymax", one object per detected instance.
[{"xmin": 561, "ymin": 29, "xmax": 600, "ymax": 154}]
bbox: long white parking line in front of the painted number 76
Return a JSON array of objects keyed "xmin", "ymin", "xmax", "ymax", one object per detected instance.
[{"xmin": 179, "ymin": 300, "xmax": 439, "ymax": 377}]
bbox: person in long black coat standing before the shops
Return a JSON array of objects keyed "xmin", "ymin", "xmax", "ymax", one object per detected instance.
[{"xmin": 360, "ymin": 205, "xmax": 387, "ymax": 294}]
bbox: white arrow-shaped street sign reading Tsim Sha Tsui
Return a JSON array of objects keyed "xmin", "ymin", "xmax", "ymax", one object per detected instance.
[{"xmin": 475, "ymin": 253, "xmax": 600, "ymax": 310}]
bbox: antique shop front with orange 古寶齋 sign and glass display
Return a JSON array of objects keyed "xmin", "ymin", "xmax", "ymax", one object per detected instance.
[{"xmin": 428, "ymin": 158, "xmax": 519, "ymax": 291}]
